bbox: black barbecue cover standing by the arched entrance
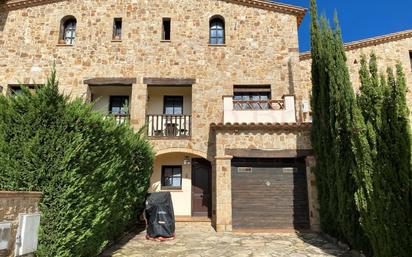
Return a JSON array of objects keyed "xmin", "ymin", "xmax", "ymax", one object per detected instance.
[{"xmin": 145, "ymin": 192, "xmax": 175, "ymax": 238}]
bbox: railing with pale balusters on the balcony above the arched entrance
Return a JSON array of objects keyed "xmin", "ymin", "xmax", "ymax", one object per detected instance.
[{"xmin": 146, "ymin": 114, "xmax": 192, "ymax": 137}]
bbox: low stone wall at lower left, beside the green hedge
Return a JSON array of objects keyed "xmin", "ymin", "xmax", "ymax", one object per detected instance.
[{"xmin": 0, "ymin": 191, "xmax": 42, "ymax": 257}]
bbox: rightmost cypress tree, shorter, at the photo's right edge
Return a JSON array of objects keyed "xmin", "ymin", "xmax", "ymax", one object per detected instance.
[{"xmin": 371, "ymin": 64, "xmax": 412, "ymax": 257}]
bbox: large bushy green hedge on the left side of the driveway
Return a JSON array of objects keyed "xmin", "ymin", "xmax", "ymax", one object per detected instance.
[{"xmin": 0, "ymin": 72, "xmax": 154, "ymax": 257}]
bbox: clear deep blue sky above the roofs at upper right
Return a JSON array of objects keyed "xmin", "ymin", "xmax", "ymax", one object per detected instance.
[{"xmin": 275, "ymin": 0, "xmax": 412, "ymax": 52}]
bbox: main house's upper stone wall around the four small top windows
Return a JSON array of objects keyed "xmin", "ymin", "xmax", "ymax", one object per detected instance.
[{"xmin": 0, "ymin": 0, "xmax": 299, "ymax": 156}]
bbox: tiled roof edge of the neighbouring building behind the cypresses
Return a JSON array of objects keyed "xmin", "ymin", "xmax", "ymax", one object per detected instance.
[{"xmin": 300, "ymin": 29, "xmax": 412, "ymax": 61}]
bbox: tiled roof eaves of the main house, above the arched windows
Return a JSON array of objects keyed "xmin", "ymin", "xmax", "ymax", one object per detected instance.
[{"xmin": 0, "ymin": 0, "xmax": 307, "ymax": 26}]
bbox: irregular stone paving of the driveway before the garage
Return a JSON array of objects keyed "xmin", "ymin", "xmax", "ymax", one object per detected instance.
[{"xmin": 101, "ymin": 224, "xmax": 351, "ymax": 257}]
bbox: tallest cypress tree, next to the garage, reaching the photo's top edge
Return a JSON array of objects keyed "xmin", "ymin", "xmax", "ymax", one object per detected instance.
[{"xmin": 311, "ymin": 0, "xmax": 370, "ymax": 249}]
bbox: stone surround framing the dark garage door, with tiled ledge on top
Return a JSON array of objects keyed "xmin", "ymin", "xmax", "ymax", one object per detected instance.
[{"xmin": 212, "ymin": 127, "xmax": 319, "ymax": 231}]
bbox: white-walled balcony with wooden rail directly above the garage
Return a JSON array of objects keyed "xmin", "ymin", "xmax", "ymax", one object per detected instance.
[{"xmin": 223, "ymin": 95, "xmax": 296, "ymax": 123}]
